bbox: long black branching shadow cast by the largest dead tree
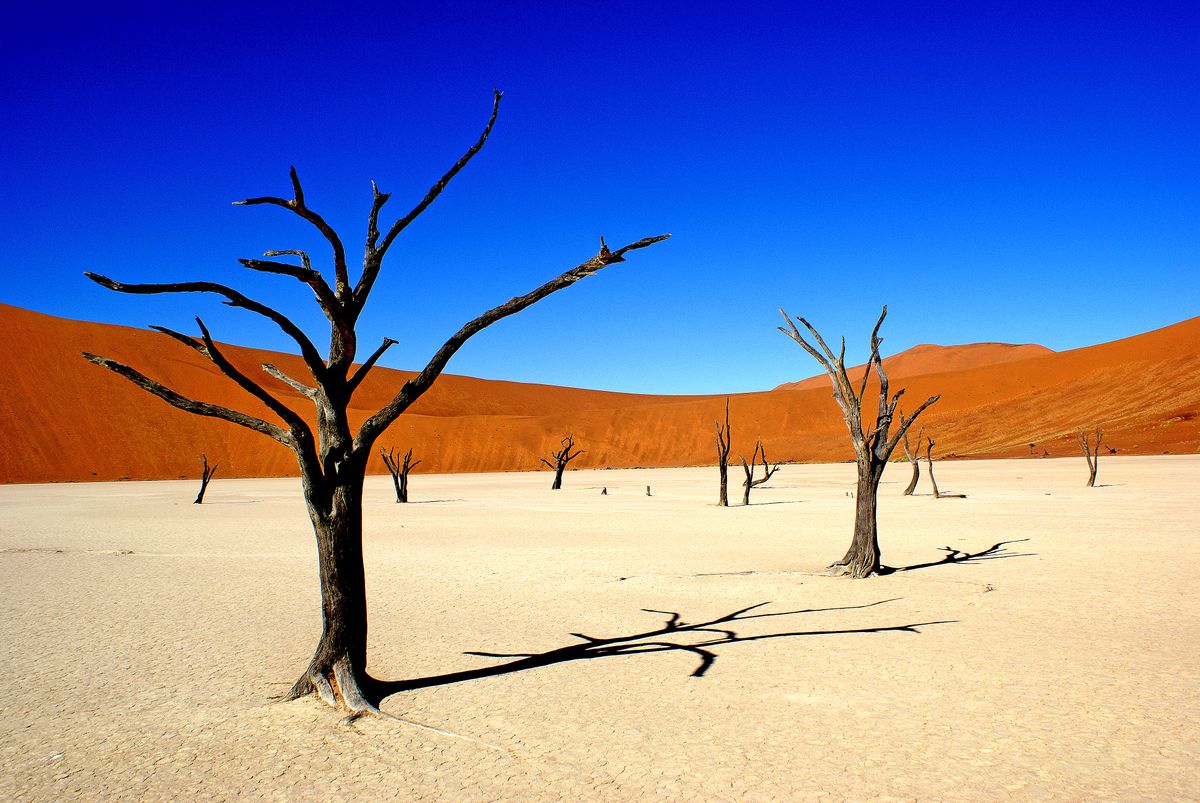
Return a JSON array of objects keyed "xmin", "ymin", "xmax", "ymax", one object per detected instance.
[{"xmin": 372, "ymin": 598, "xmax": 954, "ymax": 700}]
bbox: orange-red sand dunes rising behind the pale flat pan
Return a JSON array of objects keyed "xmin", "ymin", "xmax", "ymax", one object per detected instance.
[{"xmin": 0, "ymin": 305, "xmax": 1200, "ymax": 483}]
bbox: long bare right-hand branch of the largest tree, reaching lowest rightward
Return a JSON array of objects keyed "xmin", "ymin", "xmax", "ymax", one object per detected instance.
[{"xmin": 354, "ymin": 234, "xmax": 671, "ymax": 449}]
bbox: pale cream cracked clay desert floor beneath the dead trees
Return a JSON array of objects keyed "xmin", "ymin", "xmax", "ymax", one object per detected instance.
[{"xmin": 0, "ymin": 456, "xmax": 1200, "ymax": 801}]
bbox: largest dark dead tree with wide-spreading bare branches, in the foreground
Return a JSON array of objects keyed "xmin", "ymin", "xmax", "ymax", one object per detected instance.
[{"xmin": 84, "ymin": 91, "xmax": 668, "ymax": 717}]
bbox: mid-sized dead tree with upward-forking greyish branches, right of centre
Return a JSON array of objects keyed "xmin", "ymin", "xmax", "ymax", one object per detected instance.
[{"xmin": 779, "ymin": 306, "xmax": 941, "ymax": 577}]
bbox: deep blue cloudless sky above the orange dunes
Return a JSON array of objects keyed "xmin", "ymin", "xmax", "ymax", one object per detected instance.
[{"xmin": 0, "ymin": 2, "xmax": 1200, "ymax": 392}]
